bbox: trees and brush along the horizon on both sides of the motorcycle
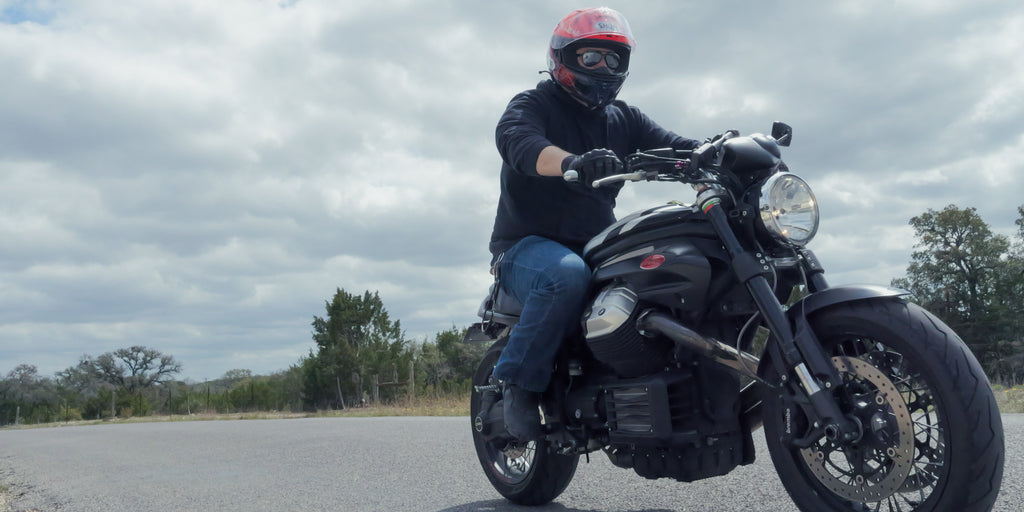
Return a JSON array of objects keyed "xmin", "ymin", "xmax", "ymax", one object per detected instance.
[{"xmin": 0, "ymin": 205, "xmax": 1024, "ymax": 426}]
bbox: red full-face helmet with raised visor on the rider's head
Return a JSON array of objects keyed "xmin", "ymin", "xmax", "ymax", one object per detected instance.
[{"xmin": 548, "ymin": 7, "xmax": 636, "ymax": 109}]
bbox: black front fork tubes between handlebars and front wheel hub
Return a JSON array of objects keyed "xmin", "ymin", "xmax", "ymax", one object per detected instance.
[{"xmin": 697, "ymin": 186, "xmax": 861, "ymax": 447}]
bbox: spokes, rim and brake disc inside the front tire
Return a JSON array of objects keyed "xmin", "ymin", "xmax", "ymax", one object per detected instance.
[{"xmin": 803, "ymin": 338, "xmax": 945, "ymax": 512}]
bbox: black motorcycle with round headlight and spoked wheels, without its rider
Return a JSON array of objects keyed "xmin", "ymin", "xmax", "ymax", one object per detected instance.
[{"xmin": 466, "ymin": 123, "xmax": 1005, "ymax": 512}]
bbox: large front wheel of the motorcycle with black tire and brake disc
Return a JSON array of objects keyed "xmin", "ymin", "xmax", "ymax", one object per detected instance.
[{"xmin": 764, "ymin": 300, "xmax": 1004, "ymax": 512}]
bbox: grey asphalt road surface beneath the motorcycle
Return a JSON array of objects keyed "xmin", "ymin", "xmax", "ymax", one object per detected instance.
[{"xmin": 0, "ymin": 415, "xmax": 1024, "ymax": 512}]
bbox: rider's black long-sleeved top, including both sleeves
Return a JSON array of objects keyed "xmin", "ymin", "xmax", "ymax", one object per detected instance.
[{"xmin": 490, "ymin": 80, "xmax": 698, "ymax": 257}]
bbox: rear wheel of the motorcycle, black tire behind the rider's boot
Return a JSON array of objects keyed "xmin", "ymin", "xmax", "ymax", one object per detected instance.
[{"xmin": 470, "ymin": 339, "xmax": 580, "ymax": 505}]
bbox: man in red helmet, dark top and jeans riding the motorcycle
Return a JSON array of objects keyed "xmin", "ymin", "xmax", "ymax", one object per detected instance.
[{"xmin": 489, "ymin": 7, "xmax": 698, "ymax": 441}]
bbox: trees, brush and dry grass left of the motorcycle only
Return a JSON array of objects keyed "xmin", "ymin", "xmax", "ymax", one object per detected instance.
[{"xmin": 0, "ymin": 289, "xmax": 486, "ymax": 426}]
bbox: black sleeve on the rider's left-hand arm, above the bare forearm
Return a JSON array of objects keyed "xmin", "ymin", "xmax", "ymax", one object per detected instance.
[{"xmin": 495, "ymin": 91, "xmax": 554, "ymax": 176}]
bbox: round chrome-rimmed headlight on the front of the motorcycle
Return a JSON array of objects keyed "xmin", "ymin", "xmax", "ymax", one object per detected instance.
[{"xmin": 760, "ymin": 172, "xmax": 818, "ymax": 246}]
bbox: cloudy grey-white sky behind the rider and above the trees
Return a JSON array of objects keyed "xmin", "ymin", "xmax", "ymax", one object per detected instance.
[{"xmin": 0, "ymin": 0, "xmax": 1024, "ymax": 381}]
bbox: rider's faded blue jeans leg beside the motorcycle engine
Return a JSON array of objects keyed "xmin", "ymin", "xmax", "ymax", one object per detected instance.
[{"xmin": 495, "ymin": 237, "xmax": 591, "ymax": 391}]
